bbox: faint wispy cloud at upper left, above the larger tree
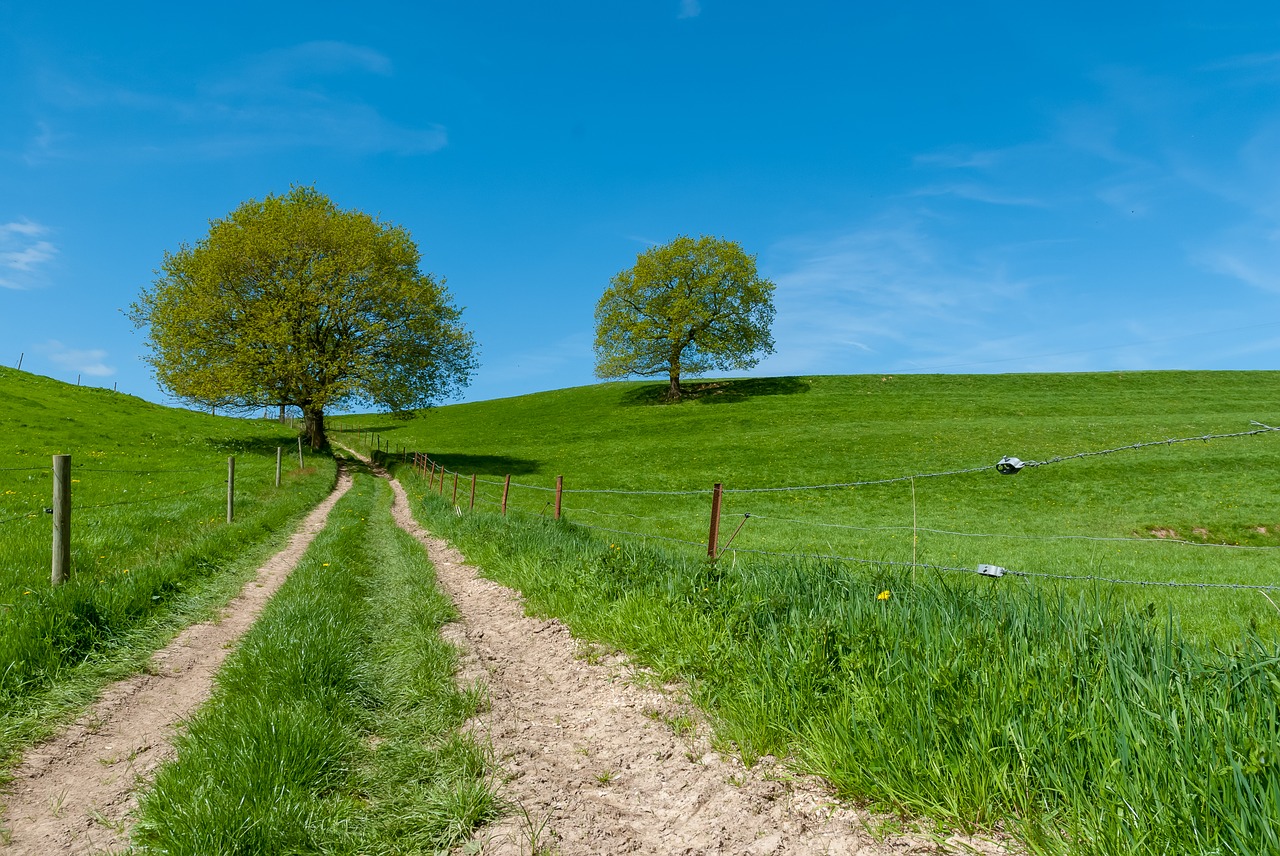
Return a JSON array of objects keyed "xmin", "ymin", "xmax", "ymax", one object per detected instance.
[{"xmin": 28, "ymin": 41, "xmax": 448, "ymax": 160}]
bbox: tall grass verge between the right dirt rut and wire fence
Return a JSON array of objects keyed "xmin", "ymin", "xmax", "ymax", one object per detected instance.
[{"xmin": 411, "ymin": 481, "xmax": 1280, "ymax": 856}]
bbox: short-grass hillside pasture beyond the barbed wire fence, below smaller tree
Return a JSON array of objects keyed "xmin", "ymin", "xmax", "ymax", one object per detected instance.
[{"xmin": 332, "ymin": 372, "xmax": 1280, "ymax": 640}]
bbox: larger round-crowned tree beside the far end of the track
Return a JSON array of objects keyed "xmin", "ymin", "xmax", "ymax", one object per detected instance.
[{"xmin": 129, "ymin": 187, "xmax": 476, "ymax": 448}]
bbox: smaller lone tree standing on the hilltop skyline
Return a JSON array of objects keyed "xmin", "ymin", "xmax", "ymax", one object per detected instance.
[{"xmin": 595, "ymin": 235, "xmax": 773, "ymax": 399}]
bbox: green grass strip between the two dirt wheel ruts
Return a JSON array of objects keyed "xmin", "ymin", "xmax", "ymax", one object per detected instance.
[{"xmin": 134, "ymin": 473, "xmax": 498, "ymax": 856}]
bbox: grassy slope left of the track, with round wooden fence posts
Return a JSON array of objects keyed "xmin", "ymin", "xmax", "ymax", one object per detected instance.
[{"xmin": 0, "ymin": 369, "xmax": 335, "ymax": 757}]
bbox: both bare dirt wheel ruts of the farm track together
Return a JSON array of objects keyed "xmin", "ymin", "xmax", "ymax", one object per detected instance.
[{"xmin": 0, "ymin": 450, "xmax": 1002, "ymax": 856}]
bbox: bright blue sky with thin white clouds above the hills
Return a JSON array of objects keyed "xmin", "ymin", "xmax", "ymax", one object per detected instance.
[{"xmin": 0, "ymin": 0, "xmax": 1280, "ymax": 400}]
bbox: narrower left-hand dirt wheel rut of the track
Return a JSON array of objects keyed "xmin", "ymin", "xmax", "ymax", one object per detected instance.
[{"xmin": 0, "ymin": 471, "xmax": 352, "ymax": 856}]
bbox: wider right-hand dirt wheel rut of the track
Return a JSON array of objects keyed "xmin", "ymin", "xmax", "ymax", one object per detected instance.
[{"xmin": 378, "ymin": 480, "xmax": 1006, "ymax": 856}]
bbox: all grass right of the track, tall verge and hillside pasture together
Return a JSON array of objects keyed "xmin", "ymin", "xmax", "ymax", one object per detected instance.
[{"xmin": 337, "ymin": 372, "xmax": 1280, "ymax": 856}]
